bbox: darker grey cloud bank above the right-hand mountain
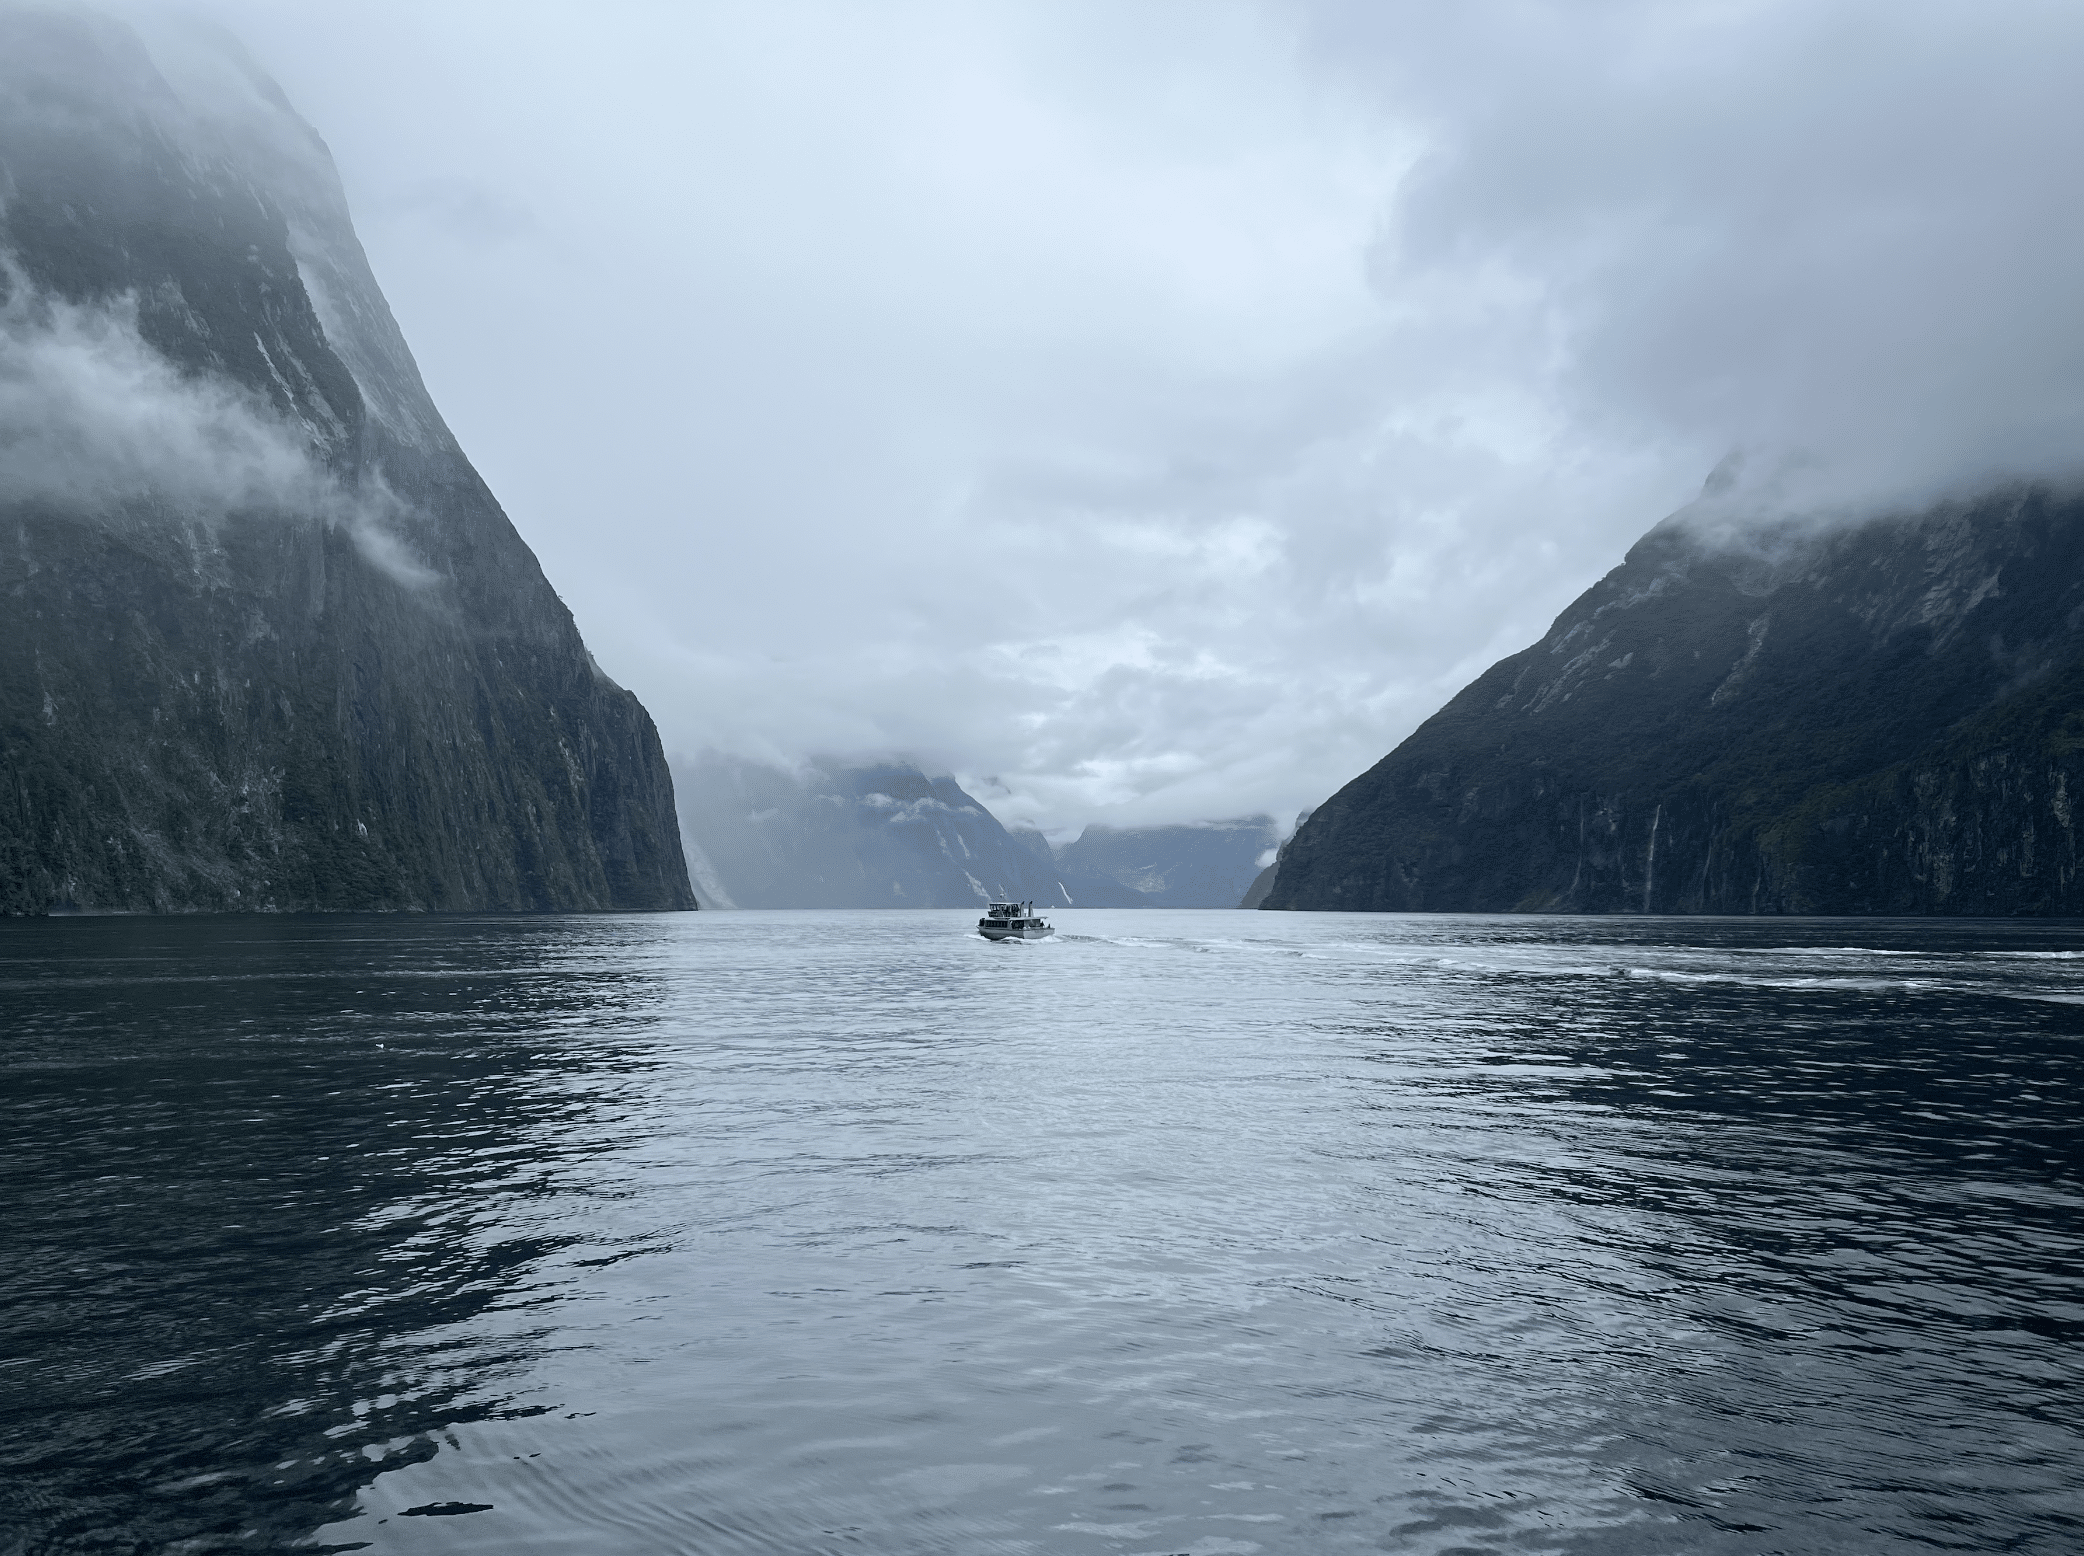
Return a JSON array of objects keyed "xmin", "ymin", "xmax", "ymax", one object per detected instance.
[{"xmin": 1309, "ymin": 0, "xmax": 2084, "ymax": 506}]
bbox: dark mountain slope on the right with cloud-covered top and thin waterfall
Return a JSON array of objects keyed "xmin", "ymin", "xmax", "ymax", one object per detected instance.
[{"xmin": 1265, "ymin": 487, "xmax": 2084, "ymax": 914}]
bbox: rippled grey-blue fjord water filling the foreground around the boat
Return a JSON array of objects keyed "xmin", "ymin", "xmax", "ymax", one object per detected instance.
[{"xmin": 0, "ymin": 910, "xmax": 2084, "ymax": 1556}]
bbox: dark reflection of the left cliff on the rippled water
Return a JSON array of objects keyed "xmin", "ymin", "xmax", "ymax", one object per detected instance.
[{"xmin": 0, "ymin": 919, "xmax": 659, "ymax": 1552}]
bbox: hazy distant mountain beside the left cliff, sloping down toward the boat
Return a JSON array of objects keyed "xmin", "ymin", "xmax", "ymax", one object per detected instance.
[{"xmin": 679, "ymin": 754, "xmax": 1092, "ymax": 908}]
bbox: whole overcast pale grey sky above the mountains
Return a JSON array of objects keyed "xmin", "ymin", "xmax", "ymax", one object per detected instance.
[{"xmin": 166, "ymin": 0, "xmax": 2084, "ymax": 829}]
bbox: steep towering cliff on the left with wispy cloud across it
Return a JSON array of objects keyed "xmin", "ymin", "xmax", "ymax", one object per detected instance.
[{"xmin": 0, "ymin": 6, "xmax": 694, "ymax": 912}]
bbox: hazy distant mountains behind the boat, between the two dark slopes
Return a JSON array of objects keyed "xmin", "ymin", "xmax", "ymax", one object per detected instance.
[{"xmin": 679, "ymin": 754, "xmax": 1275, "ymax": 908}]
